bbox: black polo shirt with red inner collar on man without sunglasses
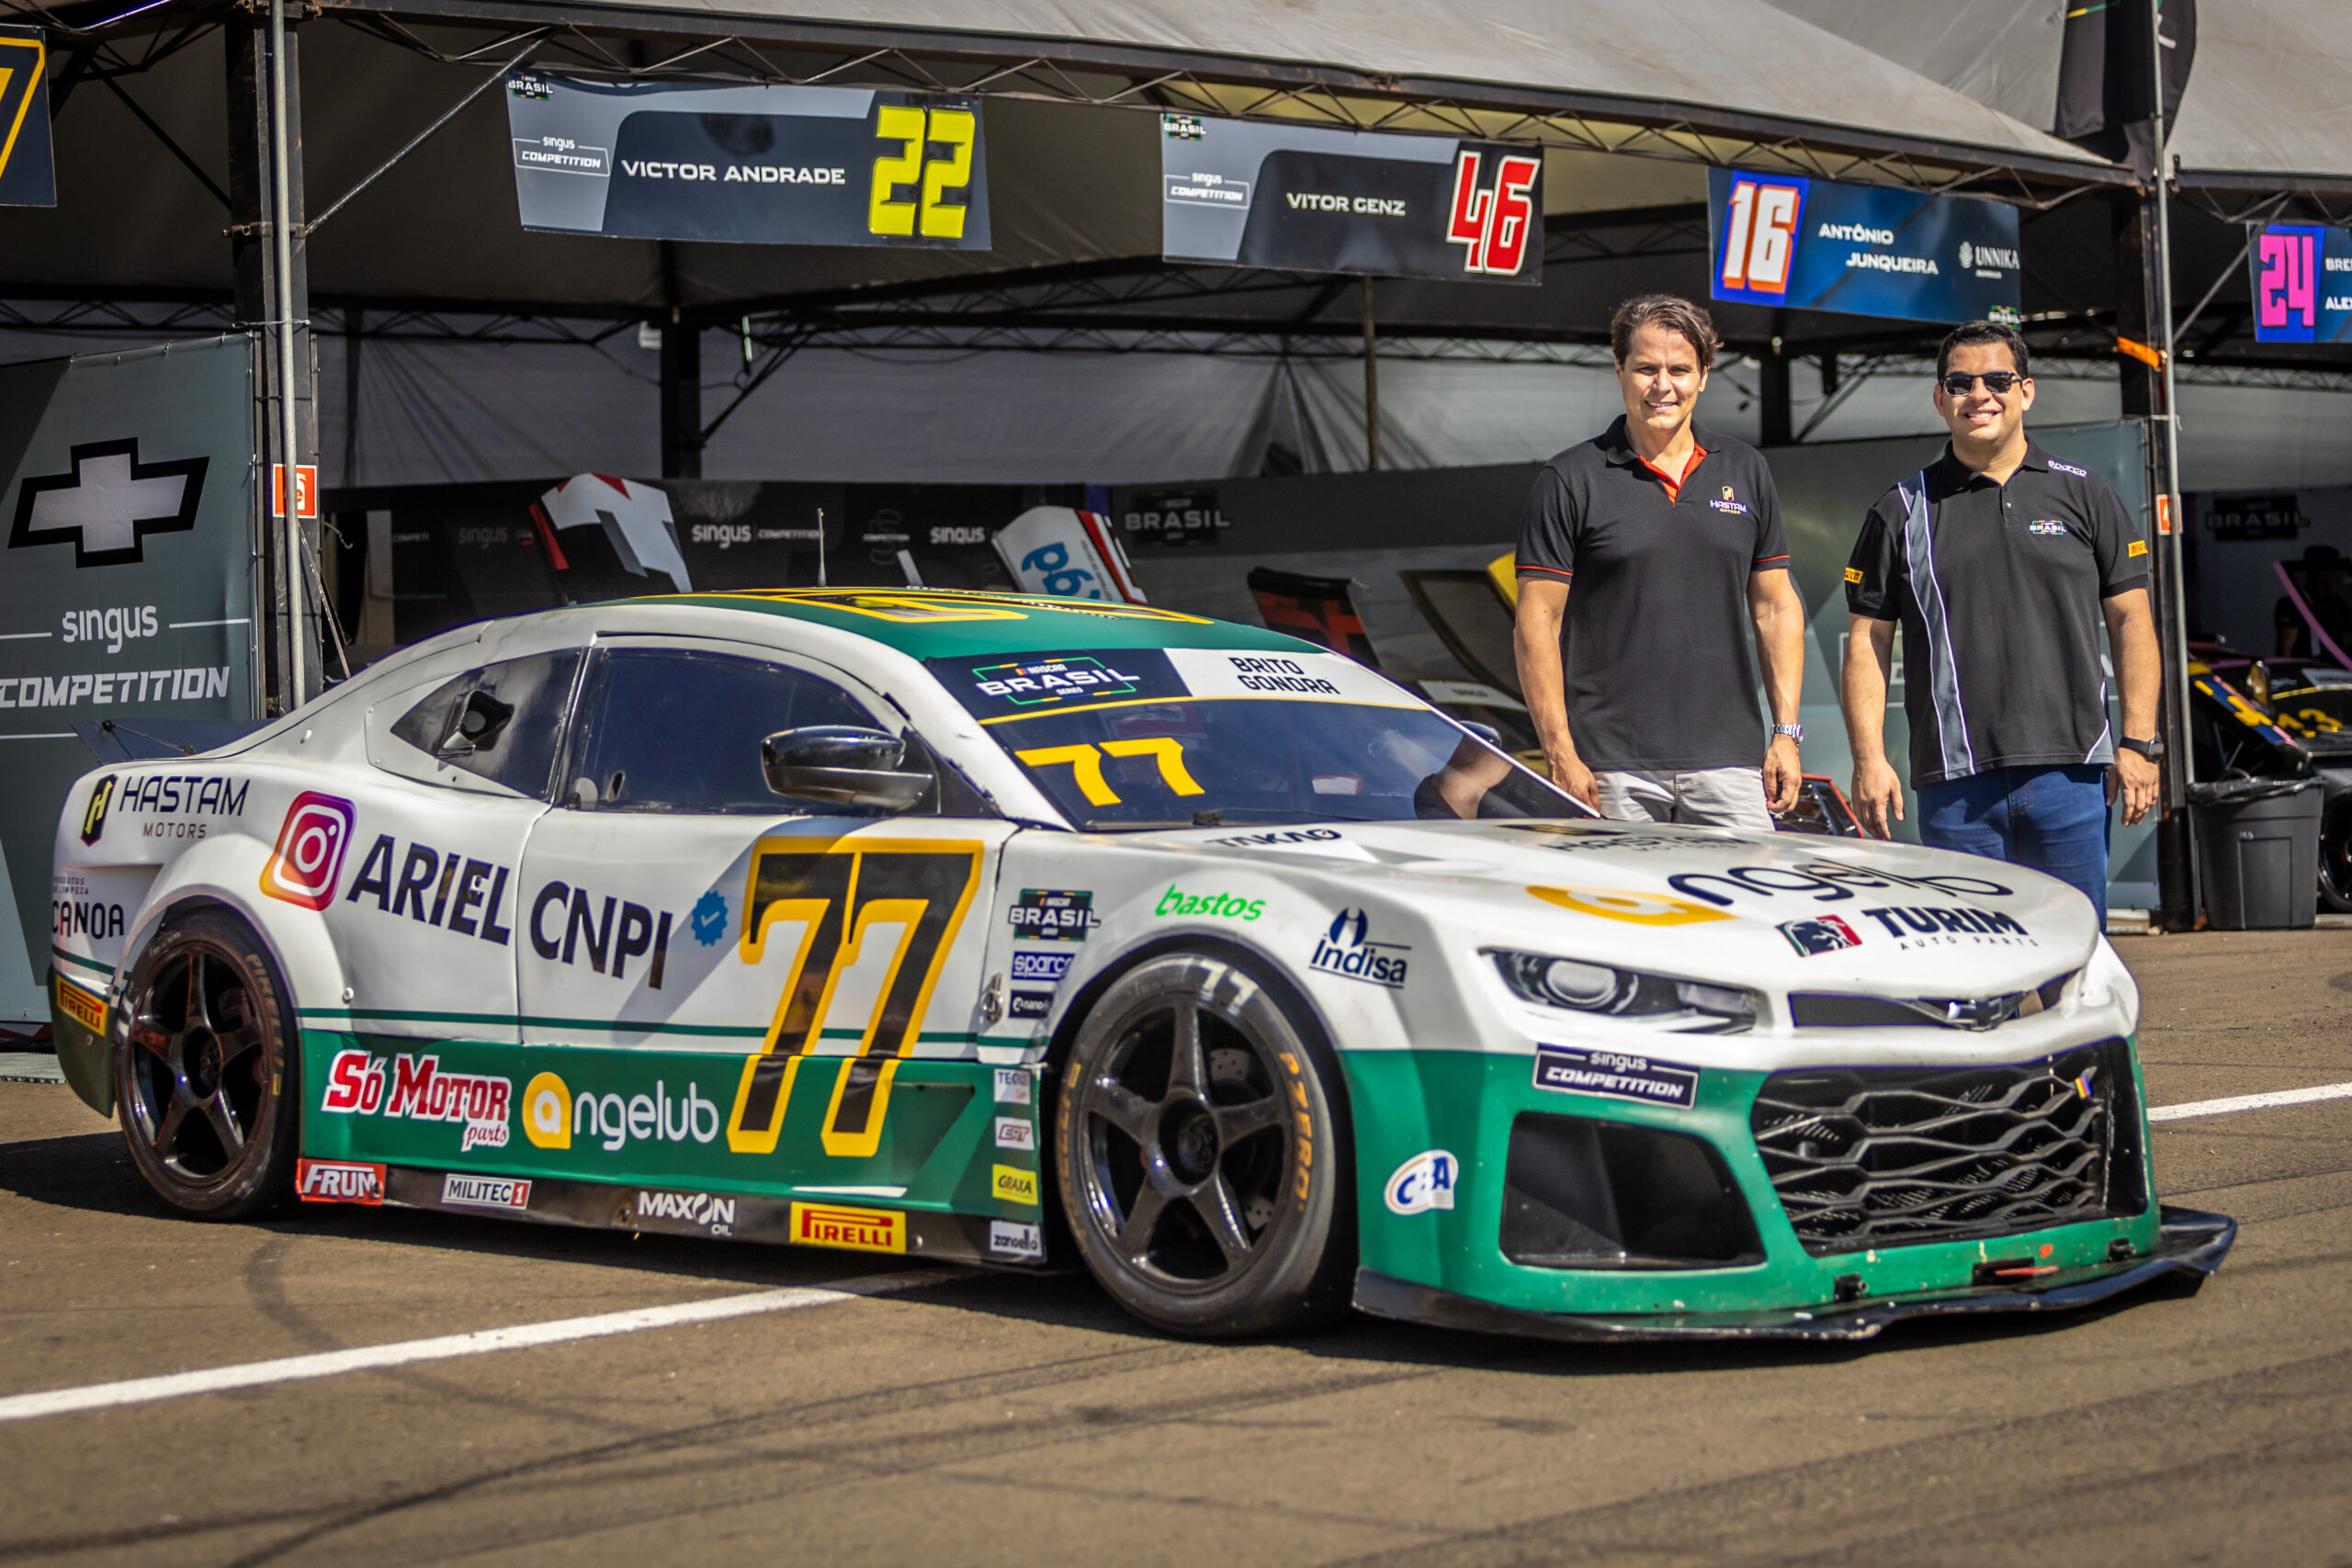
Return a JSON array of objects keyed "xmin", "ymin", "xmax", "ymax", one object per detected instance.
[{"xmin": 1517, "ymin": 419, "xmax": 1788, "ymax": 771}]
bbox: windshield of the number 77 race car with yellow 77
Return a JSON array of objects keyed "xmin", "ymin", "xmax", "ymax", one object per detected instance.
[{"xmin": 932, "ymin": 649, "xmax": 1590, "ymax": 832}]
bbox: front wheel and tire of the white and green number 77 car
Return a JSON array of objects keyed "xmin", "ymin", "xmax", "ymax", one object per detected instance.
[{"xmin": 1054, "ymin": 950, "xmax": 1355, "ymax": 1337}]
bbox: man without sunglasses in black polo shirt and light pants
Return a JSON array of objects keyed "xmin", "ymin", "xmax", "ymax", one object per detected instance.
[{"xmin": 1515, "ymin": 294, "xmax": 1804, "ymax": 832}]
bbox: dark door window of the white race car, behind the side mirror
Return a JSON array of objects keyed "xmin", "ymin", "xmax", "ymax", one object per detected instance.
[{"xmin": 562, "ymin": 649, "xmax": 912, "ymax": 816}]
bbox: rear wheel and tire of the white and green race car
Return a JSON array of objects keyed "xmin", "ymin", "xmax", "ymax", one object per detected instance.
[{"xmin": 115, "ymin": 908, "xmax": 301, "ymax": 1220}]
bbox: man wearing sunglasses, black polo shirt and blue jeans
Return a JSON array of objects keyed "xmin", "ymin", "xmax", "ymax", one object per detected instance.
[{"xmin": 1841, "ymin": 322, "xmax": 2159, "ymax": 924}]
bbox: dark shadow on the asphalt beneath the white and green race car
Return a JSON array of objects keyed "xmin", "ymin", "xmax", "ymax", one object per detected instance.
[{"xmin": 0, "ymin": 1134, "xmax": 2201, "ymax": 1378}]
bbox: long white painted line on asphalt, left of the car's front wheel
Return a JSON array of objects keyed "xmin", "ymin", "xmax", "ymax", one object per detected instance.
[{"xmin": 0, "ymin": 1269, "xmax": 953, "ymax": 1422}]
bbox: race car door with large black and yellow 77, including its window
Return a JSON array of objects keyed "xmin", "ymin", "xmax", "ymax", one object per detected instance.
[{"xmin": 515, "ymin": 637, "xmax": 1012, "ymax": 1197}]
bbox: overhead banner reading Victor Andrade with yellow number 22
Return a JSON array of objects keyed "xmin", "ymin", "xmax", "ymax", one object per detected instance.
[{"xmin": 505, "ymin": 71, "xmax": 988, "ymax": 252}]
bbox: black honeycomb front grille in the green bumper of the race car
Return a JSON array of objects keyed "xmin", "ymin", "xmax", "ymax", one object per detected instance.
[{"xmin": 1747, "ymin": 1039, "xmax": 2147, "ymax": 1256}]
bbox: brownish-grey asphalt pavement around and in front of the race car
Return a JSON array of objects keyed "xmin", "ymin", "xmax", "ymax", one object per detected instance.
[{"xmin": 0, "ymin": 931, "xmax": 2352, "ymax": 1568}]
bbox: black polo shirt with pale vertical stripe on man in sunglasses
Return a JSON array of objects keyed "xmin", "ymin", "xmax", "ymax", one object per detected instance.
[{"xmin": 1847, "ymin": 440, "xmax": 2147, "ymax": 787}]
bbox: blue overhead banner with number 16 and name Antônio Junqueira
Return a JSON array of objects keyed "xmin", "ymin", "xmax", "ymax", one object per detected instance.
[{"xmin": 1708, "ymin": 169, "xmax": 2023, "ymax": 322}]
